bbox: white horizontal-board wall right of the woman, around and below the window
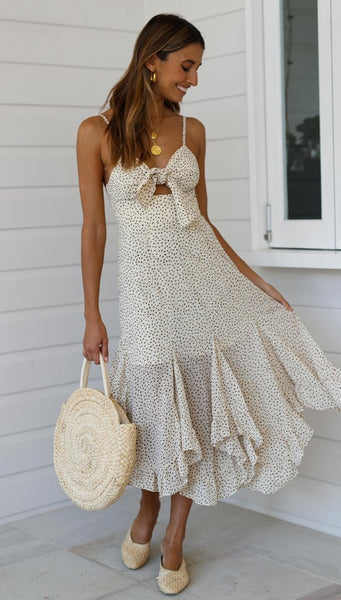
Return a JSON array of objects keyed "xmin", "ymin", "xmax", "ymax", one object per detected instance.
[{"xmin": 145, "ymin": 0, "xmax": 341, "ymax": 535}]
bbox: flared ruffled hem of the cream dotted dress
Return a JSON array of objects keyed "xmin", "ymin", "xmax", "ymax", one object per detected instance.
[{"xmin": 110, "ymin": 311, "xmax": 341, "ymax": 505}]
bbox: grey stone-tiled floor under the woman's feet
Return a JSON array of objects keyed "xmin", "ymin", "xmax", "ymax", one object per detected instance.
[{"xmin": 0, "ymin": 487, "xmax": 341, "ymax": 600}]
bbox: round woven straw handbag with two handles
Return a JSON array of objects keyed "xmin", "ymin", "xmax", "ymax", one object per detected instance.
[{"xmin": 53, "ymin": 353, "xmax": 137, "ymax": 510}]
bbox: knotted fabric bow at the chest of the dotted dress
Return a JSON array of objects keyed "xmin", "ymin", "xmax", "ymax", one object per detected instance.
[{"xmin": 136, "ymin": 164, "xmax": 201, "ymax": 227}]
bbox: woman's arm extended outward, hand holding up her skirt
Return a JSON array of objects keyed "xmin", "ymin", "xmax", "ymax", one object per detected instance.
[{"xmin": 193, "ymin": 119, "xmax": 293, "ymax": 310}]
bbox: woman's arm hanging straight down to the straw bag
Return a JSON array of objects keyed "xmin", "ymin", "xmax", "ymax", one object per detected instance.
[{"xmin": 77, "ymin": 117, "xmax": 108, "ymax": 364}]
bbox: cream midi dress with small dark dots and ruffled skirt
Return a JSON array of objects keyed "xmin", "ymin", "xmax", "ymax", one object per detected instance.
[{"xmin": 102, "ymin": 113, "xmax": 341, "ymax": 505}]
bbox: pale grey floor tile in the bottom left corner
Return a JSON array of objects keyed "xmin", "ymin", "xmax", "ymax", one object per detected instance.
[{"xmin": 0, "ymin": 550, "xmax": 132, "ymax": 600}]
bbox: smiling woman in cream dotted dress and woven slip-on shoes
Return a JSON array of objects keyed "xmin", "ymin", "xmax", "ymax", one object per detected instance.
[{"xmin": 77, "ymin": 14, "xmax": 341, "ymax": 593}]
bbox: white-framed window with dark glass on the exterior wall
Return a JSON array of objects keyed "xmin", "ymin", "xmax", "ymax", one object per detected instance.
[{"xmin": 245, "ymin": 0, "xmax": 341, "ymax": 268}]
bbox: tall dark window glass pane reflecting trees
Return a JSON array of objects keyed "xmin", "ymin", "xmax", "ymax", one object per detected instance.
[{"xmin": 282, "ymin": 0, "xmax": 321, "ymax": 219}]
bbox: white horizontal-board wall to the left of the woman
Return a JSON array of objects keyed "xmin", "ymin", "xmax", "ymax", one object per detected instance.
[{"xmin": 0, "ymin": 0, "xmax": 143, "ymax": 521}]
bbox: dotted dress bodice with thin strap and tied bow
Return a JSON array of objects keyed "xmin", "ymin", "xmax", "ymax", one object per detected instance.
[{"xmin": 102, "ymin": 115, "xmax": 201, "ymax": 227}]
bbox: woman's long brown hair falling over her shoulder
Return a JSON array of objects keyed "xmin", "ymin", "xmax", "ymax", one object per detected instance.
[{"xmin": 102, "ymin": 14, "xmax": 205, "ymax": 167}]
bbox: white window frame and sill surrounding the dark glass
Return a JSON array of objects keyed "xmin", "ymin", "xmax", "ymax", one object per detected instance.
[{"xmin": 243, "ymin": 0, "xmax": 341, "ymax": 269}]
